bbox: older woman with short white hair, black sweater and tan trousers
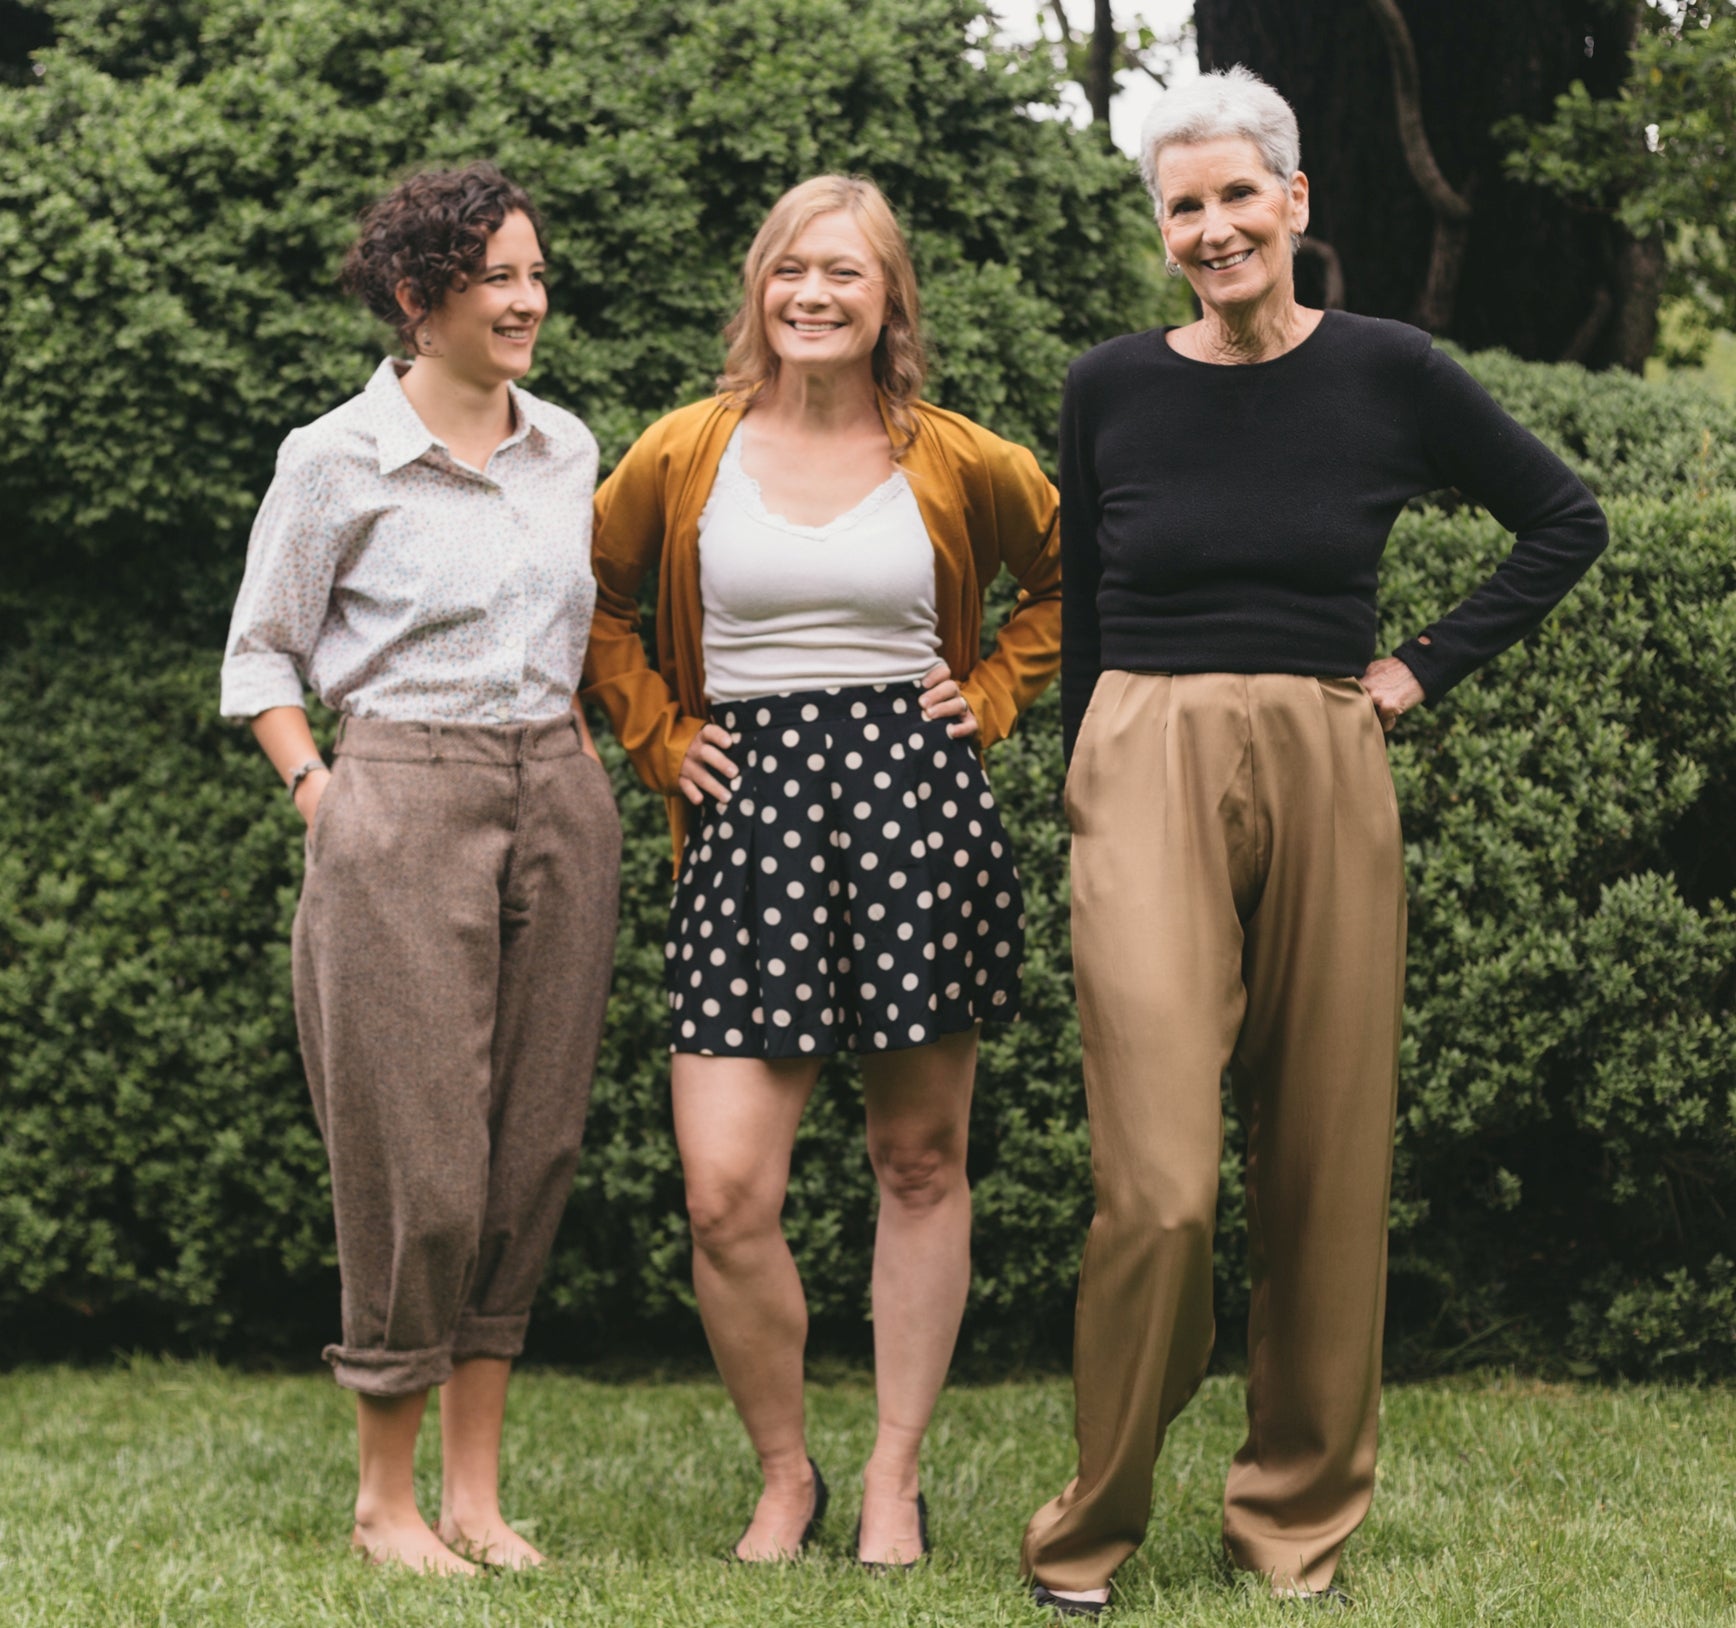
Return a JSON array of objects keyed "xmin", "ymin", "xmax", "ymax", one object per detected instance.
[{"xmin": 1024, "ymin": 68, "xmax": 1606, "ymax": 1616}]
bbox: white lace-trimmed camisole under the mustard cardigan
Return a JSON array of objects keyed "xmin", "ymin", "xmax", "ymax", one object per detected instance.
[{"xmin": 700, "ymin": 425, "xmax": 941, "ymax": 701}]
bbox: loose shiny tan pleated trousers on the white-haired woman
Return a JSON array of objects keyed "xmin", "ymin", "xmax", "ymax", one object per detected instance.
[{"xmin": 1024, "ymin": 672, "xmax": 1404, "ymax": 1590}]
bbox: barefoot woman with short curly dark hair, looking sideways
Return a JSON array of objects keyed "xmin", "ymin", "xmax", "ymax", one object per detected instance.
[{"xmin": 222, "ymin": 165, "xmax": 620, "ymax": 1572}]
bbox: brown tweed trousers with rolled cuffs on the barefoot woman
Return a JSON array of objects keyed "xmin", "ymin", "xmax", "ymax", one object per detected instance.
[{"xmin": 293, "ymin": 715, "xmax": 621, "ymax": 1395}]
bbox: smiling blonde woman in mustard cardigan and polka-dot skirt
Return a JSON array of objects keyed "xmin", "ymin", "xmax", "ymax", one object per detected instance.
[{"xmin": 583, "ymin": 175, "xmax": 1061, "ymax": 1566}]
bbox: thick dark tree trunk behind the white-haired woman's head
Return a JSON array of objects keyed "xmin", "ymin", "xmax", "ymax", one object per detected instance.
[{"xmin": 1194, "ymin": 0, "xmax": 1642, "ymax": 364}]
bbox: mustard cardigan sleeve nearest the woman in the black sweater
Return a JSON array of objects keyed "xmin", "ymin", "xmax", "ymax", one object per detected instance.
[{"xmin": 958, "ymin": 421, "xmax": 1061, "ymax": 750}]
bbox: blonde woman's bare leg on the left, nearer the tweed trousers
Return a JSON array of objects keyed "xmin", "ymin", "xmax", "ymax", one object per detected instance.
[{"xmin": 672, "ymin": 1052, "xmax": 819, "ymax": 1560}]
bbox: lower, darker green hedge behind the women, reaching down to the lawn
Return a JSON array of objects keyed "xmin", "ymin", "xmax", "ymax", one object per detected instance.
[{"xmin": 0, "ymin": 468, "xmax": 1736, "ymax": 1375}]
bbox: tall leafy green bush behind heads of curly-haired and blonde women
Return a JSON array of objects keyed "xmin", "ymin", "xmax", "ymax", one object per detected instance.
[{"xmin": 0, "ymin": 0, "xmax": 1149, "ymax": 590}]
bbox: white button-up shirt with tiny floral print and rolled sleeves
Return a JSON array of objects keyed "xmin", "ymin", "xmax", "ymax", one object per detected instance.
[{"xmin": 222, "ymin": 359, "xmax": 597, "ymax": 724}]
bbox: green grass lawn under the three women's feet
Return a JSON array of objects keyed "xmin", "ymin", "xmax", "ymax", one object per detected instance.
[{"xmin": 0, "ymin": 1362, "xmax": 1736, "ymax": 1628}]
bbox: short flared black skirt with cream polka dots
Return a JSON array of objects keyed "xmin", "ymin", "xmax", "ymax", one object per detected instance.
[{"xmin": 665, "ymin": 684, "xmax": 1024, "ymax": 1057}]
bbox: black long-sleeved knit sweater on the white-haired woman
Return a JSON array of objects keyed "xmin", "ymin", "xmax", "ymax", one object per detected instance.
[{"xmin": 1061, "ymin": 311, "xmax": 1608, "ymax": 758}]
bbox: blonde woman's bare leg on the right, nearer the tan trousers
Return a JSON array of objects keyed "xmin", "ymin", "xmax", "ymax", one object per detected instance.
[{"xmin": 859, "ymin": 1029, "xmax": 977, "ymax": 1562}]
